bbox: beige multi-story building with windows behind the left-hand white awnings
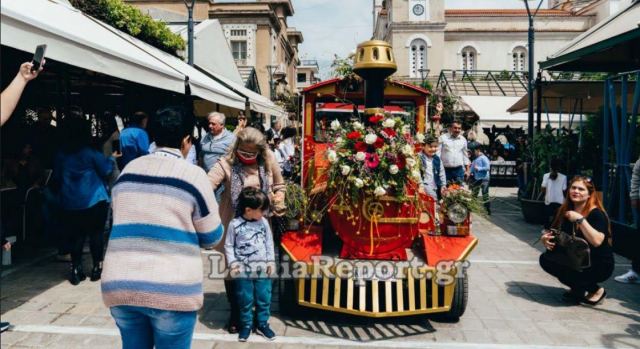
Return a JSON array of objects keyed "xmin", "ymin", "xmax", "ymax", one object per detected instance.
[{"xmin": 126, "ymin": 0, "xmax": 303, "ymax": 98}]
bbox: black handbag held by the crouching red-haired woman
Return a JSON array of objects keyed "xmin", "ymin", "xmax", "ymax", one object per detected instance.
[{"xmin": 544, "ymin": 224, "xmax": 591, "ymax": 271}]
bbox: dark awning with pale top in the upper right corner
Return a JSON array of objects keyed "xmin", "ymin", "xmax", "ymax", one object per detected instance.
[{"xmin": 540, "ymin": 0, "xmax": 640, "ymax": 72}]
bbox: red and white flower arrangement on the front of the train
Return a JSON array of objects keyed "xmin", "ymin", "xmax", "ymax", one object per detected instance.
[{"xmin": 326, "ymin": 114, "xmax": 420, "ymax": 201}]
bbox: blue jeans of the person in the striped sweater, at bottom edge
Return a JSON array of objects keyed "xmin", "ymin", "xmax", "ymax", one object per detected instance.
[{"xmin": 111, "ymin": 305, "xmax": 197, "ymax": 349}]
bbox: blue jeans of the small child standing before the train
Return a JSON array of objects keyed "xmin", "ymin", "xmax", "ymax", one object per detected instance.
[{"xmin": 235, "ymin": 278, "xmax": 272, "ymax": 328}]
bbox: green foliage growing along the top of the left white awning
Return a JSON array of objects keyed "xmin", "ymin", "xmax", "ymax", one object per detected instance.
[{"xmin": 70, "ymin": 0, "xmax": 186, "ymax": 56}]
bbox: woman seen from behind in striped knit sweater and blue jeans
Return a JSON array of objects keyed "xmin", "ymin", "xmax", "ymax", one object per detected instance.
[{"xmin": 102, "ymin": 107, "xmax": 223, "ymax": 349}]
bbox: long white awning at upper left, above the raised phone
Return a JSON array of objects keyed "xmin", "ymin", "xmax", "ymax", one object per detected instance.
[{"xmin": 0, "ymin": 0, "xmax": 244, "ymax": 109}]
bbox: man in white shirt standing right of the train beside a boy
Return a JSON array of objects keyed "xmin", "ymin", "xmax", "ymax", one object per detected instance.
[{"xmin": 438, "ymin": 120, "xmax": 471, "ymax": 183}]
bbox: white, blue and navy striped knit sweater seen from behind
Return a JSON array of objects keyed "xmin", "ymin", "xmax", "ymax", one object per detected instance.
[{"xmin": 102, "ymin": 148, "xmax": 223, "ymax": 311}]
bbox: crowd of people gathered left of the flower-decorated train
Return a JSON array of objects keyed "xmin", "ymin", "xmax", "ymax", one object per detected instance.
[{"xmin": 2, "ymin": 64, "xmax": 299, "ymax": 342}]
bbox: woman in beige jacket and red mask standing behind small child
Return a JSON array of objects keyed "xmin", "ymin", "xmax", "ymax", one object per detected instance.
[{"xmin": 208, "ymin": 127, "xmax": 286, "ymax": 333}]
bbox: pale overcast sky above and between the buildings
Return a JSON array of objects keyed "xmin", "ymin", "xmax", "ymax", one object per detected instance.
[{"xmin": 288, "ymin": 0, "xmax": 546, "ymax": 77}]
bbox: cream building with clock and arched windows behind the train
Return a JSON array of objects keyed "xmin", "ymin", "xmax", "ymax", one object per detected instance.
[{"xmin": 373, "ymin": 0, "xmax": 629, "ymax": 81}]
